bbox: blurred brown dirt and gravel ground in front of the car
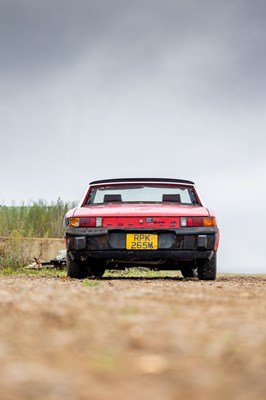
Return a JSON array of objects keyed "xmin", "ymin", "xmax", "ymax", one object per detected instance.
[{"xmin": 0, "ymin": 275, "xmax": 266, "ymax": 400}]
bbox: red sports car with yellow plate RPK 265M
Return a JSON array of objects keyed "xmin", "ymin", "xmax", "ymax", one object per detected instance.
[{"xmin": 64, "ymin": 178, "xmax": 219, "ymax": 280}]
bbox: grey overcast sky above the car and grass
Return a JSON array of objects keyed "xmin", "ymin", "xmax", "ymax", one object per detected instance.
[{"xmin": 0, "ymin": 0, "xmax": 266, "ymax": 272}]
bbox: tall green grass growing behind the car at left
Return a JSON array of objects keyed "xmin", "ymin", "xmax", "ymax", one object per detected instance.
[{"xmin": 0, "ymin": 199, "xmax": 74, "ymax": 238}]
